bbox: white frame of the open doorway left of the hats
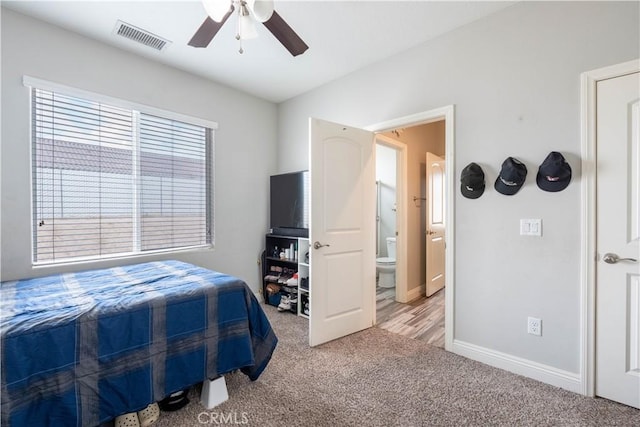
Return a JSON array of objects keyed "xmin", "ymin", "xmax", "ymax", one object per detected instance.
[{"xmin": 364, "ymin": 104, "xmax": 456, "ymax": 351}]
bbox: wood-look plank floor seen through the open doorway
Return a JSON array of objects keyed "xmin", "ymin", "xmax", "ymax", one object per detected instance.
[{"xmin": 376, "ymin": 287, "xmax": 445, "ymax": 348}]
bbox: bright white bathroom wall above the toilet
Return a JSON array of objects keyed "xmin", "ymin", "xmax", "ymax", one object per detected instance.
[{"xmin": 376, "ymin": 144, "xmax": 397, "ymax": 257}]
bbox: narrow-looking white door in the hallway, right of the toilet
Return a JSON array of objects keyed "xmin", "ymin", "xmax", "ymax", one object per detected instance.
[{"xmin": 426, "ymin": 152, "xmax": 445, "ymax": 296}]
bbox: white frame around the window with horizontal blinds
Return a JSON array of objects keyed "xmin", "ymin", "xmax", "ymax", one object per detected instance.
[{"xmin": 23, "ymin": 75, "xmax": 218, "ymax": 267}]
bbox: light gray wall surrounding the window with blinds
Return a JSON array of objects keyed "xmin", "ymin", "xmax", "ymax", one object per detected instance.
[{"xmin": 0, "ymin": 9, "xmax": 277, "ymax": 291}]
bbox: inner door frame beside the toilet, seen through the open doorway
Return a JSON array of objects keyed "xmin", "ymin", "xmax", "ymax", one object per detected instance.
[{"xmin": 375, "ymin": 133, "xmax": 409, "ymax": 303}]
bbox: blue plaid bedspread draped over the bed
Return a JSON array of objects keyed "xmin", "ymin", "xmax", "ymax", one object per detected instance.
[{"xmin": 0, "ymin": 261, "xmax": 278, "ymax": 427}]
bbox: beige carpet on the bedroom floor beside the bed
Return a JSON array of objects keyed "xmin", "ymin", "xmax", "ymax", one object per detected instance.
[{"xmin": 151, "ymin": 306, "xmax": 640, "ymax": 427}]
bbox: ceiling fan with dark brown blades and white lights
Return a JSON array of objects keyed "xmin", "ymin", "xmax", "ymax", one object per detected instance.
[{"xmin": 188, "ymin": 0, "xmax": 309, "ymax": 56}]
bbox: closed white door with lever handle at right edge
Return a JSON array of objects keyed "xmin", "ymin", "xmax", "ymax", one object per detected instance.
[{"xmin": 596, "ymin": 73, "xmax": 640, "ymax": 408}]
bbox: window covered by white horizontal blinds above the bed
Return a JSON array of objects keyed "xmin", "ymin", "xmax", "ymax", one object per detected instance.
[{"xmin": 32, "ymin": 83, "xmax": 213, "ymax": 263}]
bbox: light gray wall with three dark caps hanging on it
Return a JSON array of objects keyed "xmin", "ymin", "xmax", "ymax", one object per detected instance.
[{"xmin": 278, "ymin": 2, "xmax": 640, "ymax": 373}]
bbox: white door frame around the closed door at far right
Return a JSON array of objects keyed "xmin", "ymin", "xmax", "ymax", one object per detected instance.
[{"xmin": 580, "ymin": 59, "xmax": 640, "ymax": 397}]
